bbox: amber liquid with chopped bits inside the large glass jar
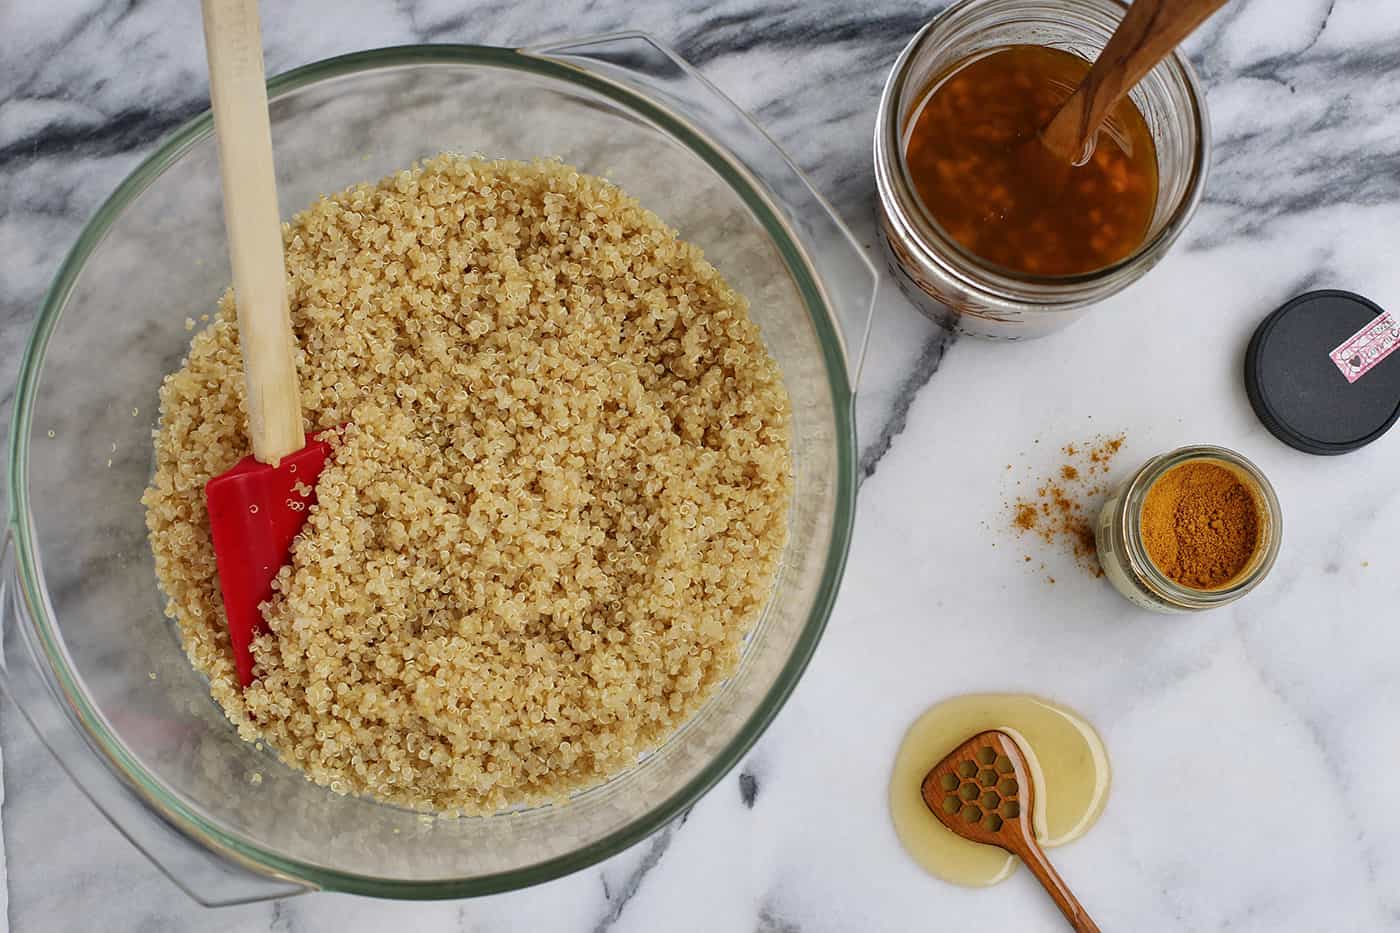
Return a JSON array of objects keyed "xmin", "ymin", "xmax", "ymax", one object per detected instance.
[{"xmin": 904, "ymin": 45, "xmax": 1158, "ymax": 276}]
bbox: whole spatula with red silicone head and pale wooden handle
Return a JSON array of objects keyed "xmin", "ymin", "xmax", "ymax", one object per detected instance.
[{"xmin": 203, "ymin": 0, "xmax": 330, "ymax": 686}]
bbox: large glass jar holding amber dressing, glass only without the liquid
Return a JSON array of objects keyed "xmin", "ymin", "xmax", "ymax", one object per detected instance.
[{"xmin": 875, "ymin": 0, "xmax": 1210, "ymax": 339}]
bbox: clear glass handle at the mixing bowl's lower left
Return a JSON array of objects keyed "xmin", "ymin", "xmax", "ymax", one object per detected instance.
[{"xmin": 0, "ymin": 518, "xmax": 311, "ymax": 906}]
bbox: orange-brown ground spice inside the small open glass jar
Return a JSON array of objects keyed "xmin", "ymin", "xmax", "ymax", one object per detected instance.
[{"xmin": 1142, "ymin": 461, "xmax": 1259, "ymax": 590}]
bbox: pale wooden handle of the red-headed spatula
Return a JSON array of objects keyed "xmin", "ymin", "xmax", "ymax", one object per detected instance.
[{"xmin": 203, "ymin": 0, "xmax": 307, "ymax": 464}]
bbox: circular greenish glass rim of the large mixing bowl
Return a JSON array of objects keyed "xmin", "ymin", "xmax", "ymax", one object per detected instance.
[{"xmin": 7, "ymin": 39, "xmax": 855, "ymax": 899}]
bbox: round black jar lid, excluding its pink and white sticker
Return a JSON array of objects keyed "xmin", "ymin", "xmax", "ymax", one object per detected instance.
[{"xmin": 1245, "ymin": 289, "xmax": 1400, "ymax": 454}]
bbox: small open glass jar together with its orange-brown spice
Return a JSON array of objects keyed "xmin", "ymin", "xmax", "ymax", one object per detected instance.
[{"xmin": 1095, "ymin": 445, "xmax": 1282, "ymax": 612}]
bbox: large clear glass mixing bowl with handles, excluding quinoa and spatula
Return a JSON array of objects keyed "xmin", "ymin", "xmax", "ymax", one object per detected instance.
[{"xmin": 0, "ymin": 34, "xmax": 876, "ymax": 904}]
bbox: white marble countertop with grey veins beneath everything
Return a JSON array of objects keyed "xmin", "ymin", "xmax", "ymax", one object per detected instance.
[{"xmin": 0, "ymin": 0, "xmax": 1400, "ymax": 933}]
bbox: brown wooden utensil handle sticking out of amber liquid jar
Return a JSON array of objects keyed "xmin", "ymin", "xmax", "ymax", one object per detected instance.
[{"xmin": 1040, "ymin": 0, "xmax": 1226, "ymax": 163}]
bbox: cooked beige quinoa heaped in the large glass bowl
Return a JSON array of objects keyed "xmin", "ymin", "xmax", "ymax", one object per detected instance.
[{"xmin": 143, "ymin": 156, "xmax": 791, "ymax": 813}]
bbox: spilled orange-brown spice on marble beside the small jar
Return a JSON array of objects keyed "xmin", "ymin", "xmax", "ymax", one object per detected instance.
[{"xmin": 1009, "ymin": 434, "xmax": 1126, "ymax": 583}]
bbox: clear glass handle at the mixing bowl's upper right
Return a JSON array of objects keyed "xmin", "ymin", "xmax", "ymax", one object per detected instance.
[{"xmin": 521, "ymin": 32, "xmax": 879, "ymax": 391}]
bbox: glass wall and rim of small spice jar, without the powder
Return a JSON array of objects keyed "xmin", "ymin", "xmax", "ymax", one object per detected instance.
[{"xmin": 1093, "ymin": 445, "xmax": 1284, "ymax": 612}]
